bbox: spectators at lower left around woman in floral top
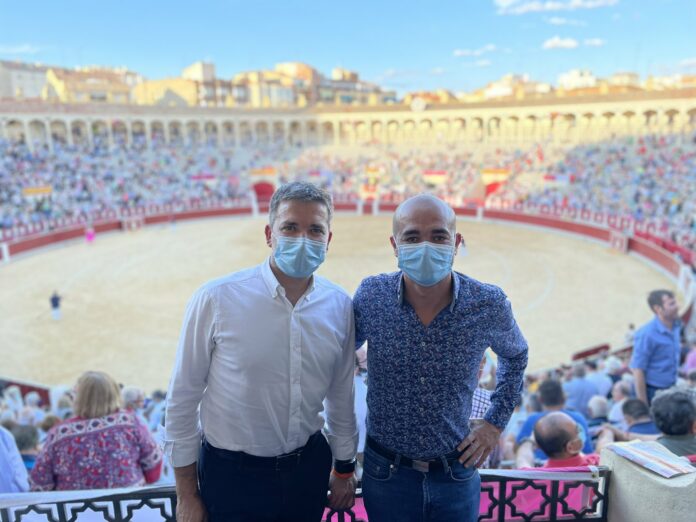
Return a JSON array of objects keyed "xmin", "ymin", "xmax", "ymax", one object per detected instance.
[{"xmin": 0, "ymin": 372, "xmax": 173, "ymax": 493}]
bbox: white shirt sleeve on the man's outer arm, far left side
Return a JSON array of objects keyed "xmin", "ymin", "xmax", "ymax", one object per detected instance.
[{"xmin": 164, "ymin": 288, "xmax": 215, "ymax": 467}]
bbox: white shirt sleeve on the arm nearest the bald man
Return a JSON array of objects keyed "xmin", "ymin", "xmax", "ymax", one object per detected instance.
[{"xmin": 326, "ymin": 300, "xmax": 358, "ymax": 460}]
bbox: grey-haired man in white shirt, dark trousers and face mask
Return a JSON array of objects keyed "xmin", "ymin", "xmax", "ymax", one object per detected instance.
[{"xmin": 165, "ymin": 182, "xmax": 358, "ymax": 522}]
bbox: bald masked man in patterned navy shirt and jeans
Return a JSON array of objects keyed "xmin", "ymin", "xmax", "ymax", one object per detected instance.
[{"xmin": 353, "ymin": 195, "xmax": 527, "ymax": 522}]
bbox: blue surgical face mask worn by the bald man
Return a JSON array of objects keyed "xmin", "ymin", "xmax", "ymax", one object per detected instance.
[{"xmin": 398, "ymin": 241, "xmax": 454, "ymax": 286}]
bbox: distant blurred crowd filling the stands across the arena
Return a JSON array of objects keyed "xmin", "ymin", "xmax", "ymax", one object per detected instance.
[{"xmin": 0, "ymin": 135, "xmax": 696, "ymax": 255}]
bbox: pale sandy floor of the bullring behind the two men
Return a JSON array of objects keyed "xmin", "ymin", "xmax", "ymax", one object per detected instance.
[{"xmin": 0, "ymin": 215, "xmax": 674, "ymax": 391}]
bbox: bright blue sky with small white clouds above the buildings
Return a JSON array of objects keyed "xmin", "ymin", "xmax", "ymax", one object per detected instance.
[{"xmin": 0, "ymin": 0, "xmax": 696, "ymax": 93}]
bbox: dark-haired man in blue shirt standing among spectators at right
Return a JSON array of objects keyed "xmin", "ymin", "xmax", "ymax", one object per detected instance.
[{"xmin": 630, "ymin": 290, "xmax": 682, "ymax": 405}]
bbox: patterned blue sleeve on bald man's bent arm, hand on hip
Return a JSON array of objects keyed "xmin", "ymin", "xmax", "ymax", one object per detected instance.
[{"xmin": 484, "ymin": 291, "xmax": 528, "ymax": 430}]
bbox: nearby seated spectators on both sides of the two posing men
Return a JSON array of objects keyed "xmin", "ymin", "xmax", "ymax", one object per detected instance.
[{"xmin": 0, "ymin": 338, "xmax": 696, "ymax": 492}]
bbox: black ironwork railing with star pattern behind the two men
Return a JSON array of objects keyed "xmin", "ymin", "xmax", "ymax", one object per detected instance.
[{"xmin": 0, "ymin": 467, "xmax": 611, "ymax": 522}]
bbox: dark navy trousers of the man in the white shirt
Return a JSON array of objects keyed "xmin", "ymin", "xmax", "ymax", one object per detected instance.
[{"xmin": 198, "ymin": 432, "xmax": 332, "ymax": 522}]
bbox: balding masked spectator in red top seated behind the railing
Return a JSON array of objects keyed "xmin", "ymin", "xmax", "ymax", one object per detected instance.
[{"xmin": 516, "ymin": 411, "xmax": 607, "ymax": 468}]
